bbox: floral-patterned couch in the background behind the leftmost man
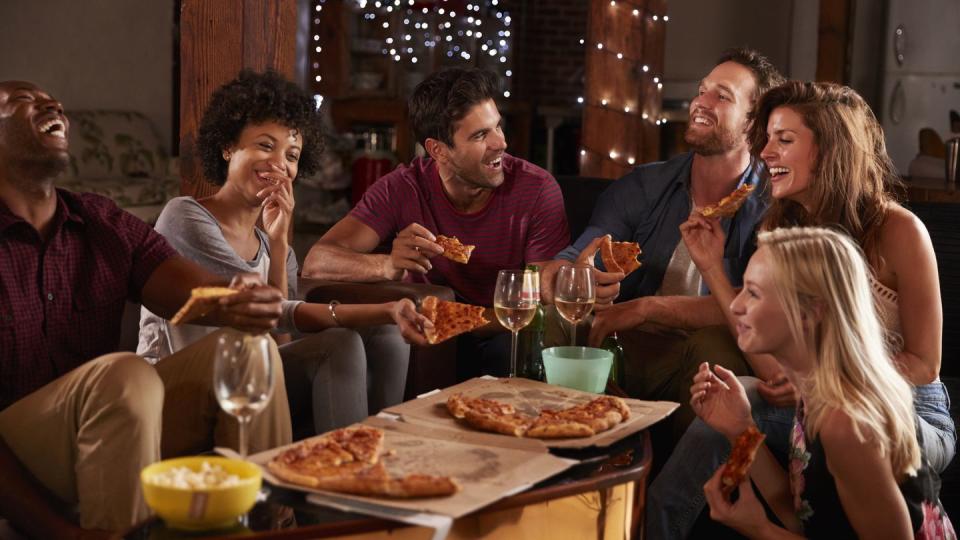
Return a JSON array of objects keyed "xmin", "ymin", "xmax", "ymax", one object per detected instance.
[{"xmin": 57, "ymin": 110, "xmax": 180, "ymax": 224}]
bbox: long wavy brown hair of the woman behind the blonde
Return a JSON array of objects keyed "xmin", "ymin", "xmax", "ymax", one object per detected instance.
[{"xmin": 749, "ymin": 81, "xmax": 900, "ymax": 267}]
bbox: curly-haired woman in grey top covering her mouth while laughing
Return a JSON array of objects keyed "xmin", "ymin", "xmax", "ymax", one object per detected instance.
[{"xmin": 137, "ymin": 70, "xmax": 429, "ymax": 438}]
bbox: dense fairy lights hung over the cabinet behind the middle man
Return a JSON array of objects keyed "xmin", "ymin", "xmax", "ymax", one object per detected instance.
[{"xmin": 311, "ymin": 0, "xmax": 513, "ymax": 107}]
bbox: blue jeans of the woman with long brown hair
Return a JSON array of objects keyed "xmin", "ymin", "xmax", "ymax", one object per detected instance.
[{"xmin": 645, "ymin": 377, "xmax": 957, "ymax": 540}]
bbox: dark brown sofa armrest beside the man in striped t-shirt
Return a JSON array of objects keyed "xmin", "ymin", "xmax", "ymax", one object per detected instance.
[{"xmin": 298, "ymin": 278, "xmax": 457, "ymax": 396}]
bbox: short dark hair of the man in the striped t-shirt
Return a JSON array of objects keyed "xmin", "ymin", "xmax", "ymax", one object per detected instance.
[{"xmin": 407, "ymin": 68, "xmax": 499, "ymax": 146}]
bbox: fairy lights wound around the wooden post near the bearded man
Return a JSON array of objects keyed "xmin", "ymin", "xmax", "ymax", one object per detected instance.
[{"xmin": 577, "ymin": 0, "xmax": 670, "ymax": 166}]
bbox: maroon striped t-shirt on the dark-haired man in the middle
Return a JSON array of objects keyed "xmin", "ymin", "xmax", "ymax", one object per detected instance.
[{"xmin": 350, "ymin": 155, "xmax": 570, "ymax": 306}]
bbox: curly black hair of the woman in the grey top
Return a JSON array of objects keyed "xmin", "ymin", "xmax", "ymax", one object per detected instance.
[{"xmin": 197, "ymin": 69, "xmax": 323, "ymax": 186}]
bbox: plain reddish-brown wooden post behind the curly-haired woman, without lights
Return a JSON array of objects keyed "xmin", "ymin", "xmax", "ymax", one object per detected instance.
[{"xmin": 180, "ymin": 0, "xmax": 297, "ymax": 197}]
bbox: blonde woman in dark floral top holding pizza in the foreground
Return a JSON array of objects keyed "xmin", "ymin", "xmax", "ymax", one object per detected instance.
[{"xmin": 691, "ymin": 227, "xmax": 953, "ymax": 538}]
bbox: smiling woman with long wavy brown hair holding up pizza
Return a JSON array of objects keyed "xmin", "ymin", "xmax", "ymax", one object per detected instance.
[{"xmin": 648, "ymin": 81, "xmax": 956, "ymax": 538}]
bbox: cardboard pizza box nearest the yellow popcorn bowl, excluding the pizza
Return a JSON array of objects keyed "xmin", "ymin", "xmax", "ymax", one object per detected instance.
[{"xmin": 249, "ymin": 417, "xmax": 576, "ymax": 521}]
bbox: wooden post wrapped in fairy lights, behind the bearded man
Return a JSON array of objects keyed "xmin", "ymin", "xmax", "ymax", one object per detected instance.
[{"xmin": 580, "ymin": 0, "xmax": 667, "ymax": 178}]
